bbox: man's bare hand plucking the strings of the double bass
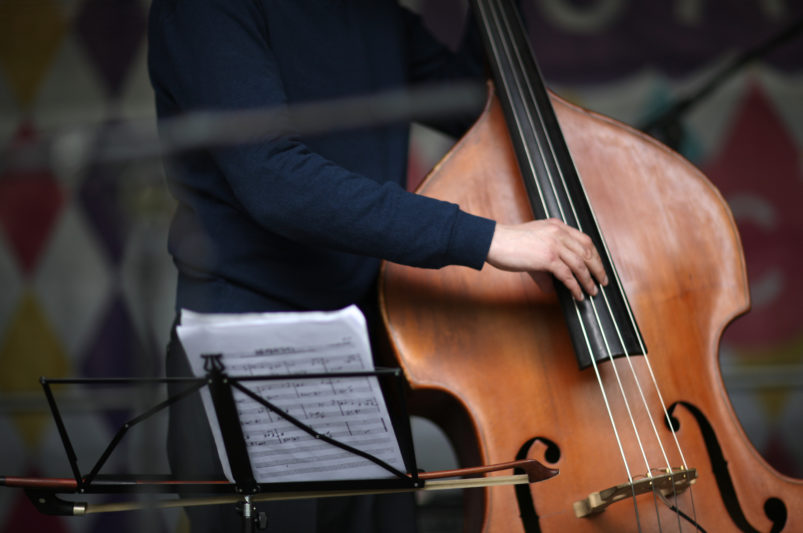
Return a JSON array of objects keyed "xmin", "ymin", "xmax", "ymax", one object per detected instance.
[{"xmin": 486, "ymin": 218, "xmax": 608, "ymax": 300}]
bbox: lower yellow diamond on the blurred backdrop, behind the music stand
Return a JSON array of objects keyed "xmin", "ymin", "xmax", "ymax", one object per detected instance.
[{"xmin": 0, "ymin": 291, "xmax": 70, "ymax": 448}]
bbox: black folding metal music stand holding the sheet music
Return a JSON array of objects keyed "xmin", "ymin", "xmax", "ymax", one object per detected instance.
[{"xmin": 17, "ymin": 354, "xmax": 424, "ymax": 532}]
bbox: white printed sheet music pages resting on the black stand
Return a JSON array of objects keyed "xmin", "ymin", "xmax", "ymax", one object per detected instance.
[{"xmin": 177, "ymin": 306, "xmax": 405, "ymax": 483}]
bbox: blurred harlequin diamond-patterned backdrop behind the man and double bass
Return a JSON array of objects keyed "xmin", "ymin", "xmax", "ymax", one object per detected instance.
[{"xmin": 0, "ymin": 0, "xmax": 803, "ymax": 533}]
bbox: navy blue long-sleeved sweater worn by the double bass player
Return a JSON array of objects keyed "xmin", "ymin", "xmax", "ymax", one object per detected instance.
[{"xmin": 149, "ymin": 0, "xmax": 494, "ymax": 312}]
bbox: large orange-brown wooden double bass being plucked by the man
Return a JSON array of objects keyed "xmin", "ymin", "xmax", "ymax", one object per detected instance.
[{"xmin": 380, "ymin": 0, "xmax": 803, "ymax": 532}]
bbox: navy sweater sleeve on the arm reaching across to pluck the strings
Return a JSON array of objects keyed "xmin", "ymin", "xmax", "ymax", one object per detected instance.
[{"xmin": 150, "ymin": 0, "xmax": 494, "ymax": 268}]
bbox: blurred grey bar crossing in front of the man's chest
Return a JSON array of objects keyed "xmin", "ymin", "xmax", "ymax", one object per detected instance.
[{"xmin": 4, "ymin": 82, "xmax": 485, "ymax": 170}]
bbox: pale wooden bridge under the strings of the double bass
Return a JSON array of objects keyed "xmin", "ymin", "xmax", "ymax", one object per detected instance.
[{"xmin": 574, "ymin": 467, "xmax": 697, "ymax": 518}]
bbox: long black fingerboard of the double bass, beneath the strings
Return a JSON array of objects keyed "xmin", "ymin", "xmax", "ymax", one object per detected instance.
[{"xmin": 472, "ymin": 0, "xmax": 645, "ymax": 369}]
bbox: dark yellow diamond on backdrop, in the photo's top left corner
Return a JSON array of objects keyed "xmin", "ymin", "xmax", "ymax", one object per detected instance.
[{"xmin": 0, "ymin": 0, "xmax": 67, "ymax": 108}]
